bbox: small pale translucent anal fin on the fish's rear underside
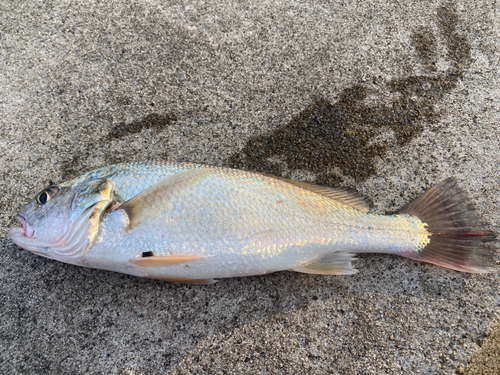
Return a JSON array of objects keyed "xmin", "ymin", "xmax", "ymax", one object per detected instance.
[{"xmin": 291, "ymin": 253, "xmax": 358, "ymax": 275}]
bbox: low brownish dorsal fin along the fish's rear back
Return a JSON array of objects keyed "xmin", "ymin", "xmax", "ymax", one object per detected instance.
[{"xmin": 256, "ymin": 172, "xmax": 370, "ymax": 213}]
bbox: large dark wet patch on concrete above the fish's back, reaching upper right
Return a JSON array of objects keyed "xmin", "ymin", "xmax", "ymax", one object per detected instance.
[{"xmin": 229, "ymin": 6, "xmax": 471, "ymax": 184}]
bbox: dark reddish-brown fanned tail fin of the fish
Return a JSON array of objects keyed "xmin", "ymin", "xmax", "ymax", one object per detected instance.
[{"xmin": 398, "ymin": 178, "xmax": 495, "ymax": 273}]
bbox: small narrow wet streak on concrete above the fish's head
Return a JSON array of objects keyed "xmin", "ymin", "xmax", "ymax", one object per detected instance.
[{"xmin": 61, "ymin": 113, "xmax": 177, "ymax": 181}]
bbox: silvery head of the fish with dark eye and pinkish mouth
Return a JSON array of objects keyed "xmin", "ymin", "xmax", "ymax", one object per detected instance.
[{"xmin": 9, "ymin": 179, "xmax": 116, "ymax": 263}]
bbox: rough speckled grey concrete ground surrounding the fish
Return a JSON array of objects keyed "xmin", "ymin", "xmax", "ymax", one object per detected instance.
[{"xmin": 0, "ymin": 0, "xmax": 500, "ymax": 374}]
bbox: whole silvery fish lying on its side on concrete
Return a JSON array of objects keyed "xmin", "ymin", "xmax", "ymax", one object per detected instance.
[{"xmin": 9, "ymin": 161, "xmax": 495, "ymax": 284}]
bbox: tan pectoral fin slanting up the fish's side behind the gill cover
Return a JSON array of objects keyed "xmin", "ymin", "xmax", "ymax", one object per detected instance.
[{"xmin": 122, "ymin": 168, "xmax": 215, "ymax": 230}]
